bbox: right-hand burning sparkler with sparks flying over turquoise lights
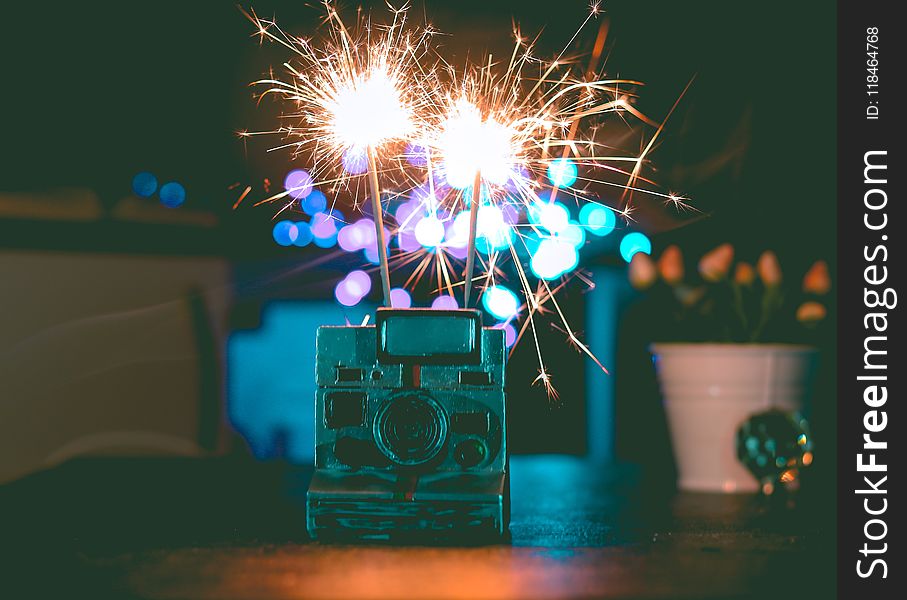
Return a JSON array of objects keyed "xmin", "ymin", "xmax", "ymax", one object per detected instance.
[{"xmin": 404, "ymin": 15, "xmax": 688, "ymax": 394}]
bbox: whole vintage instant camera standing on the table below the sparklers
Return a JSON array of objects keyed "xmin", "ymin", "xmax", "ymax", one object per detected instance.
[{"xmin": 306, "ymin": 308, "xmax": 509, "ymax": 539}]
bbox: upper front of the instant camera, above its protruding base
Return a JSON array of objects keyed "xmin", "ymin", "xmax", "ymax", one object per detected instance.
[{"xmin": 315, "ymin": 309, "xmax": 506, "ymax": 473}]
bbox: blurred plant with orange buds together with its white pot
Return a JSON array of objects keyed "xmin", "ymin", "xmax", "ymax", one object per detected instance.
[{"xmin": 629, "ymin": 244, "xmax": 831, "ymax": 492}]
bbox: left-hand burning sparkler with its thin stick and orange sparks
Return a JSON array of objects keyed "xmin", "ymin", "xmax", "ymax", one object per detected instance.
[{"xmin": 246, "ymin": 2, "xmax": 440, "ymax": 306}]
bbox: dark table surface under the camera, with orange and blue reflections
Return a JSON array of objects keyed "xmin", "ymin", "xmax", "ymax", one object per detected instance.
[{"xmin": 0, "ymin": 456, "xmax": 835, "ymax": 599}]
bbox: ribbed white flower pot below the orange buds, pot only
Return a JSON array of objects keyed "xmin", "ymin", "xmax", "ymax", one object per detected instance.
[{"xmin": 651, "ymin": 344, "xmax": 818, "ymax": 492}]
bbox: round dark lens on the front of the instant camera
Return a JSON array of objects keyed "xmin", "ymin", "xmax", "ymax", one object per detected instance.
[{"xmin": 374, "ymin": 393, "xmax": 448, "ymax": 466}]
